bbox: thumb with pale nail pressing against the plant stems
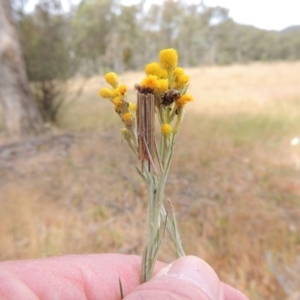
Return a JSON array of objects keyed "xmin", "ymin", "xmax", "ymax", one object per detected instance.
[{"xmin": 124, "ymin": 256, "xmax": 224, "ymax": 300}]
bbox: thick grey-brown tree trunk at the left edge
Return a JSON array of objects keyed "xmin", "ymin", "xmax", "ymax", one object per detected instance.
[{"xmin": 0, "ymin": 0, "xmax": 43, "ymax": 137}]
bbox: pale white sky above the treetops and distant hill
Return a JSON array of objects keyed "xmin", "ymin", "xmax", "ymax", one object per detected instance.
[{"xmin": 27, "ymin": 0, "xmax": 300, "ymax": 30}]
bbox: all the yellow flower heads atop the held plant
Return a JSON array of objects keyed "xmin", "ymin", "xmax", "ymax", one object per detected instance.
[{"xmin": 99, "ymin": 48, "xmax": 193, "ymax": 136}]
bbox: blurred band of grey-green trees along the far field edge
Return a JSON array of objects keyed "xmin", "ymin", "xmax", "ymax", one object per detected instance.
[{"xmin": 19, "ymin": 0, "xmax": 300, "ymax": 81}]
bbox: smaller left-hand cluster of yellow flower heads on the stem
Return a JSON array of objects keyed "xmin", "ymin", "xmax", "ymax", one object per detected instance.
[{"xmin": 99, "ymin": 72, "xmax": 136, "ymax": 126}]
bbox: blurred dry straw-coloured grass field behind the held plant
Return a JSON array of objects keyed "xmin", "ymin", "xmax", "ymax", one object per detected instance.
[{"xmin": 0, "ymin": 62, "xmax": 300, "ymax": 300}]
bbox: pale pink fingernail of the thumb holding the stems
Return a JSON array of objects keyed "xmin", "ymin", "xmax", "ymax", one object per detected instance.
[{"xmin": 155, "ymin": 256, "xmax": 223, "ymax": 300}]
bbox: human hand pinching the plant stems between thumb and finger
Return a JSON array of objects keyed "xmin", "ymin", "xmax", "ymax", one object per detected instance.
[{"xmin": 0, "ymin": 254, "xmax": 248, "ymax": 300}]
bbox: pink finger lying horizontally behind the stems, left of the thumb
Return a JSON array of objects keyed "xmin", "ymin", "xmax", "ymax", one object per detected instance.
[{"xmin": 0, "ymin": 254, "xmax": 165, "ymax": 300}]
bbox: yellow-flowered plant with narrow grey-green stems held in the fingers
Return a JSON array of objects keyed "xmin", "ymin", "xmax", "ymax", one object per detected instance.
[{"xmin": 99, "ymin": 49, "xmax": 193, "ymax": 282}]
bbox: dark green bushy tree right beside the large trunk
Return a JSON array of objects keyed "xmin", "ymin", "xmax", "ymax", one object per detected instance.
[{"xmin": 18, "ymin": 0, "xmax": 76, "ymax": 122}]
